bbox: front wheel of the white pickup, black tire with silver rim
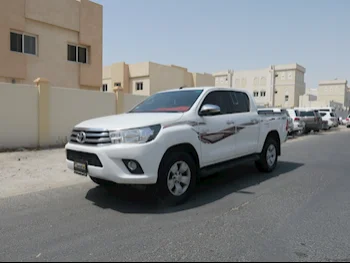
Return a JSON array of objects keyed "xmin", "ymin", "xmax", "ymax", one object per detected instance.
[{"xmin": 156, "ymin": 152, "xmax": 197, "ymax": 206}]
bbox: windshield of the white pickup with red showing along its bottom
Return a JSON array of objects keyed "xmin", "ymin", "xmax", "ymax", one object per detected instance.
[{"xmin": 129, "ymin": 89, "xmax": 203, "ymax": 113}]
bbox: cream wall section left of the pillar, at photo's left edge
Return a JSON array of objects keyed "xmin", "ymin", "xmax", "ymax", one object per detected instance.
[{"xmin": 0, "ymin": 83, "xmax": 38, "ymax": 151}]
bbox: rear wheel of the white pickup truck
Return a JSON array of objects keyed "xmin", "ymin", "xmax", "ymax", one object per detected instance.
[{"xmin": 255, "ymin": 137, "xmax": 278, "ymax": 173}]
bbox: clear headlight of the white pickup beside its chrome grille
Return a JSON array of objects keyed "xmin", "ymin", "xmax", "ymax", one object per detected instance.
[{"xmin": 109, "ymin": 125, "xmax": 161, "ymax": 144}]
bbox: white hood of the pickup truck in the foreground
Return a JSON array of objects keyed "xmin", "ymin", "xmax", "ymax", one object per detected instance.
[{"xmin": 75, "ymin": 113, "xmax": 183, "ymax": 130}]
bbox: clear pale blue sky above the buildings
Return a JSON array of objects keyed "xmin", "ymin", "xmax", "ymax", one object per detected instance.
[{"xmin": 94, "ymin": 0, "xmax": 350, "ymax": 88}]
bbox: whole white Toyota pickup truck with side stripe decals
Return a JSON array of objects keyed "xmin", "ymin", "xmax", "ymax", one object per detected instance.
[{"xmin": 66, "ymin": 87, "xmax": 288, "ymax": 204}]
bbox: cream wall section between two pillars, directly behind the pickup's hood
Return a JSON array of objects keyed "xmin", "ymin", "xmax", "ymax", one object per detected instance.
[{"xmin": 49, "ymin": 87, "xmax": 116, "ymax": 145}]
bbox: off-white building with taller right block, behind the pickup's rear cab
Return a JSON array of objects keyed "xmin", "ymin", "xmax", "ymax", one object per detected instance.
[{"xmin": 213, "ymin": 64, "xmax": 306, "ymax": 107}]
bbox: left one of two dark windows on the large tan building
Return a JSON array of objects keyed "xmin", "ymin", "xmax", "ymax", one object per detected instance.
[{"xmin": 10, "ymin": 32, "xmax": 37, "ymax": 55}]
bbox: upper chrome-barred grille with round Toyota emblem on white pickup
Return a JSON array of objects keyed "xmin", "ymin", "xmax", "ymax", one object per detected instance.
[{"xmin": 70, "ymin": 128, "xmax": 111, "ymax": 146}]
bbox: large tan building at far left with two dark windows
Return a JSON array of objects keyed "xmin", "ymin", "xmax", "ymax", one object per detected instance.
[{"xmin": 0, "ymin": 0, "xmax": 103, "ymax": 90}]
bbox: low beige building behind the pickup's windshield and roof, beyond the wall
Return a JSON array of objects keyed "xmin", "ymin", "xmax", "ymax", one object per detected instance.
[{"xmin": 102, "ymin": 62, "xmax": 215, "ymax": 96}]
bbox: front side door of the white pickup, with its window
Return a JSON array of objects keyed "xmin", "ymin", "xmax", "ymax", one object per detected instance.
[{"xmin": 199, "ymin": 90, "xmax": 236, "ymax": 166}]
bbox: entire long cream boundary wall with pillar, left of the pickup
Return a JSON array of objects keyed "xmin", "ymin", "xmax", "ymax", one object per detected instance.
[{"xmin": 0, "ymin": 79, "xmax": 117, "ymax": 150}]
